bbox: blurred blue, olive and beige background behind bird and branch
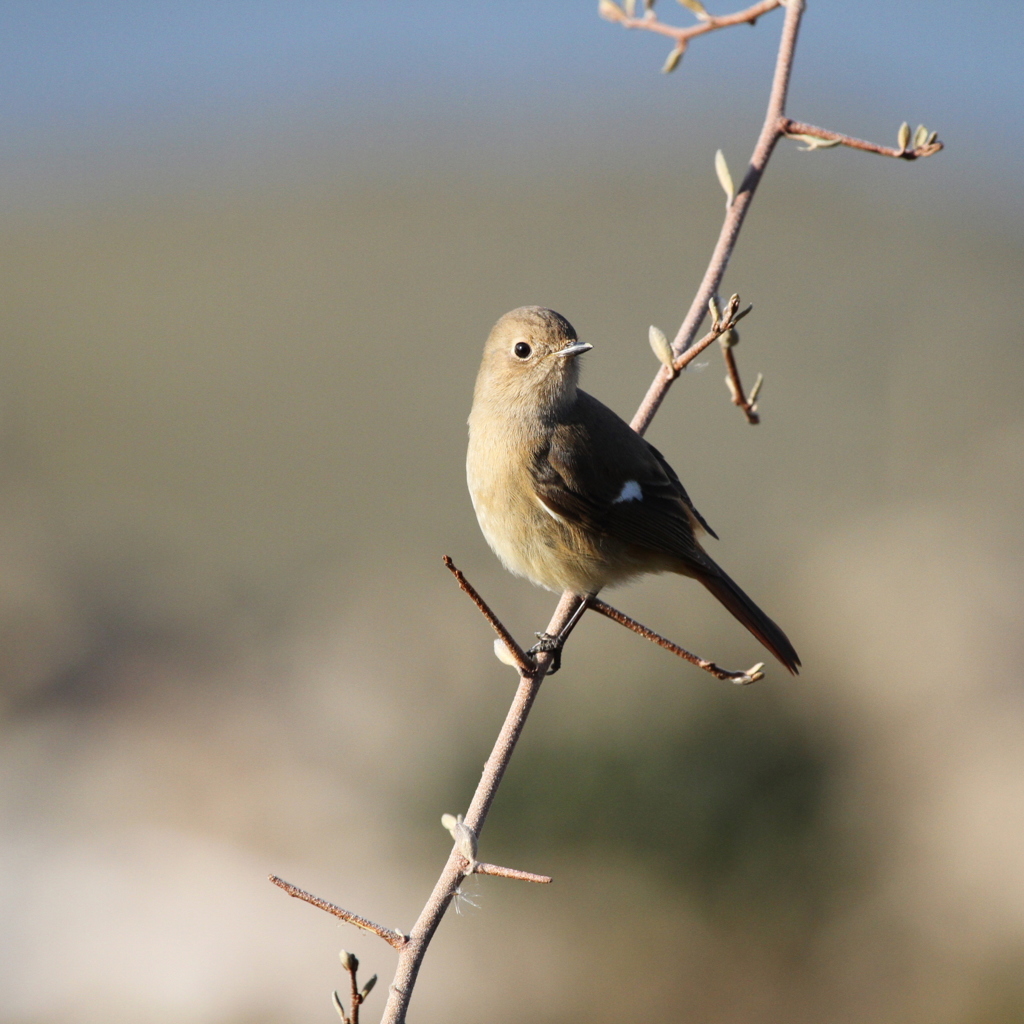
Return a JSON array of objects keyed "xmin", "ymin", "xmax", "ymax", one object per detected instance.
[{"xmin": 0, "ymin": 0, "xmax": 1024, "ymax": 1024}]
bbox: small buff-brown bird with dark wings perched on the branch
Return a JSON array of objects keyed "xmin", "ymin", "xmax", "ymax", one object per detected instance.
[{"xmin": 466, "ymin": 306, "xmax": 800, "ymax": 674}]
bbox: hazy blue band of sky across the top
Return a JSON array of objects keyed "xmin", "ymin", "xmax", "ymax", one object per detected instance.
[{"xmin": 0, "ymin": 0, "xmax": 1024, "ymax": 208}]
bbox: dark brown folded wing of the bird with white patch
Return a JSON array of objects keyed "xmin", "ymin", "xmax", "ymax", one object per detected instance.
[{"xmin": 532, "ymin": 391, "xmax": 714, "ymax": 564}]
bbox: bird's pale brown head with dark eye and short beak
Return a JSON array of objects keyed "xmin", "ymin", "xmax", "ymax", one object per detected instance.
[{"xmin": 475, "ymin": 306, "xmax": 593, "ymax": 416}]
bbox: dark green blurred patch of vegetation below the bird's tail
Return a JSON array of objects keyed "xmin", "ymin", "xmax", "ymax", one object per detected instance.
[{"xmin": 466, "ymin": 688, "xmax": 852, "ymax": 931}]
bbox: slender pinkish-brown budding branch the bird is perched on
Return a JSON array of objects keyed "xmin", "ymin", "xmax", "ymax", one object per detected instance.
[{"xmin": 271, "ymin": 0, "xmax": 942, "ymax": 1024}]
